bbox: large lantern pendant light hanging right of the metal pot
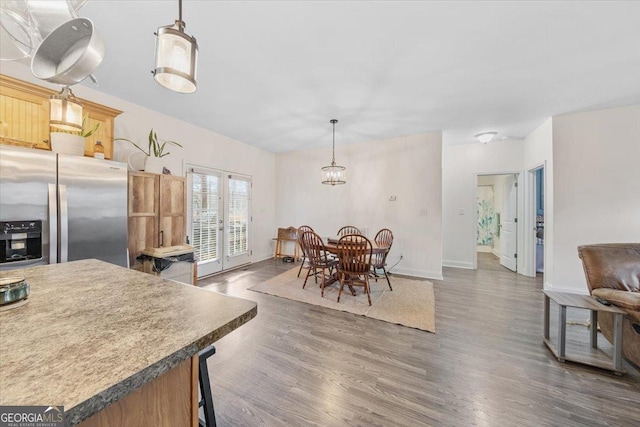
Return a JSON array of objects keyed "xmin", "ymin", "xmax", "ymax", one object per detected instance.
[{"xmin": 152, "ymin": 0, "xmax": 198, "ymax": 93}]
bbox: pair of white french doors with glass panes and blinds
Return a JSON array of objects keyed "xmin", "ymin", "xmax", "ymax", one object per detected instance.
[{"xmin": 187, "ymin": 165, "xmax": 251, "ymax": 277}]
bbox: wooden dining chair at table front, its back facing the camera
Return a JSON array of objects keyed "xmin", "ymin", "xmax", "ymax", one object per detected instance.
[{"xmin": 338, "ymin": 234, "xmax": 373, "ymax": 305}]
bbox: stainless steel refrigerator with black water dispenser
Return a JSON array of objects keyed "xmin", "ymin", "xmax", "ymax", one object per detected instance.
[{"xmin": 0, "ymin": 145, "xmax": 127, "ymax": 270}]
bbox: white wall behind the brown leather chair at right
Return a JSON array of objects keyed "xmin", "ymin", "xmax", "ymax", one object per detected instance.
[{"xmin": 545, "ymin": 105, "xmax": 640, "ymax": 293}]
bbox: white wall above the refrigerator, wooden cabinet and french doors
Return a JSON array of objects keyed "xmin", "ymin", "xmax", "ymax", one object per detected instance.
[{"xmin": 2, "ymin": 62, "xmax": 276, "ymax": 261}]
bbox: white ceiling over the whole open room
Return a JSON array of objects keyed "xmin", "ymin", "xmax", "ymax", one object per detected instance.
[{"xmin": 79, "ymin": 0, "xmax": 640, "ymax": 152}]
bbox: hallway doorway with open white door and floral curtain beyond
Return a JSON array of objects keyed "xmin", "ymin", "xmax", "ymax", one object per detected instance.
[{"xmin": 476, "ymin": 173, "xmax": 518, "ymax": 272}]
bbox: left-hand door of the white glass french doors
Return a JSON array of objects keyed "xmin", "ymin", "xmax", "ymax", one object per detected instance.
[{"xmin": 187, "ymin": 166, "xmax": 224, "ymax": 277}]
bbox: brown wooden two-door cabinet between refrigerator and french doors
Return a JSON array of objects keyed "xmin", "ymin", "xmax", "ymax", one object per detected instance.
[{"xmin": 128, "ymin": 172, "xmax": 187, "ymax": 270}]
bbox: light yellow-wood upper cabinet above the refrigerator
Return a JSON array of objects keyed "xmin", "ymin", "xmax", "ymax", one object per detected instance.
[{"xmin": 0, "ymin": 74, "xmax": 122, "ymax": 159}]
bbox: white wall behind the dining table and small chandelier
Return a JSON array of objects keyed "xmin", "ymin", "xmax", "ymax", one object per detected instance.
[{"xmin": 276, "ymin": 132, "xmax": 442, "ymax": 279}]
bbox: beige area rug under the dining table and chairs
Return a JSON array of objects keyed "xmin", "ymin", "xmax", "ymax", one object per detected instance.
[{"xmin": 249, "ymin": 268, "xmax": 436, "ymax": 333}]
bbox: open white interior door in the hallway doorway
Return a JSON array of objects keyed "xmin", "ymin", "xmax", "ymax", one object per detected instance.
[{"xmin": 500, "ymin": 175, "xmax": 518, "ymax": 271}]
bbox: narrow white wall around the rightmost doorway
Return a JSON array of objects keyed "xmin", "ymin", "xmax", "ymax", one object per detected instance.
[{"xmin": 523, "ymin": 118, "xmax": 554, "ymax": 282}]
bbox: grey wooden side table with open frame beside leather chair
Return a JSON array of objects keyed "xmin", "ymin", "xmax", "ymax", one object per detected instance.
[{"xmin": 543, "ymin": 290, "xmax": 626, "ymax": 375}]
